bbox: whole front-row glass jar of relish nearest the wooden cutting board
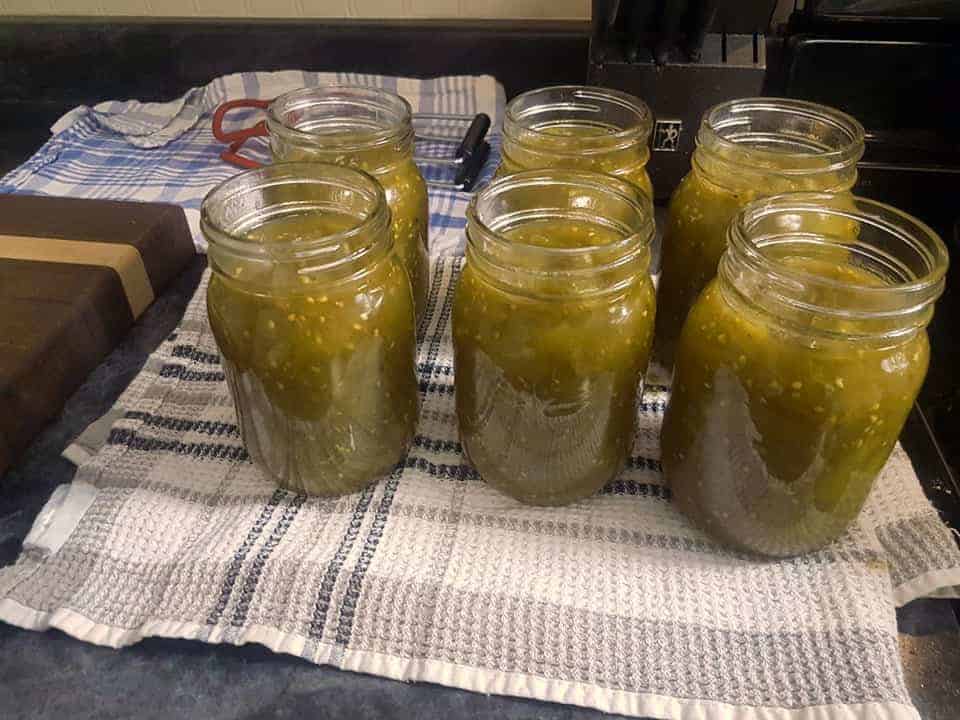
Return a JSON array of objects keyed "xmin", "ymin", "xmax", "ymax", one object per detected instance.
[{"xmin": 200, "ymin": 163, "xmax": 419, "ymax": 495}]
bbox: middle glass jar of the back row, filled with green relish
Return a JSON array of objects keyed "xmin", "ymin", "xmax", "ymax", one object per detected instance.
[{"xmin": 497, "ymin": 85, "xmax": 653, "ymax": 198}]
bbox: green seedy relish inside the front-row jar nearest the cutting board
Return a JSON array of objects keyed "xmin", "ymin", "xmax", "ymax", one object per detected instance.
[{"xmin": 207, "ymin": 212, "xmax": 419, "ymax": 495}]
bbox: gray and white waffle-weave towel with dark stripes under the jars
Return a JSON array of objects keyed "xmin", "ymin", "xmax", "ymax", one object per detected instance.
[{"xmin": 0, "ymin": 258, "xmax": 960, "ymax": 720}]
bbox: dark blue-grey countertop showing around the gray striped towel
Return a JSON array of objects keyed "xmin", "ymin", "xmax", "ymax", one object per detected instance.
[{"xmin": 0, "ymin": 257, "xmax": 960, "ymax": 720}]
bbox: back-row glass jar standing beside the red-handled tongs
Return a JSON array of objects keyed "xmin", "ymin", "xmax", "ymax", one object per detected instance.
[{"xmin": 266, "ymin": 85, "xmax": 430, "ymax": 326}]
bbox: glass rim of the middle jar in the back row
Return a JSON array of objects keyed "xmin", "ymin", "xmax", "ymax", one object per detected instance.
[{"xmin": 504, "ymin": 85, "xmax": 653, "ymax": 144}]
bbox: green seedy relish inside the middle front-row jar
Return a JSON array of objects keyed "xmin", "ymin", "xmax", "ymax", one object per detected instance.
[{"xmin": 453, "ymin": 220, "xmax": 655, "ymax": 505}]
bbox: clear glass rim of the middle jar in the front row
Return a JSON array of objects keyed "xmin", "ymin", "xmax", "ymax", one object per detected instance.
[{"xmin": 466, "ymin": 168, "xmax": 654, "ymax": 258}]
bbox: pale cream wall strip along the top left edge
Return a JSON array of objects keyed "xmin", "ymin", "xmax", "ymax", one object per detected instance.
[{"xmin": 0, "ymin": 0, "xmax": 590, "ymax": 20}]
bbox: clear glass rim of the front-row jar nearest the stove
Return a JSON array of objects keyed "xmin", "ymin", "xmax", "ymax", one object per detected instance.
[{"xmin": 721, "ymin": 192, "xmax": 949, "ymax": 334}]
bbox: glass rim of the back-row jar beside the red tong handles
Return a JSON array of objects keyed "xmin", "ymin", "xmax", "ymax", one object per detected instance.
[{"xmin": 266, "ymin": 84, "xmax": 413, "ymax": 151}]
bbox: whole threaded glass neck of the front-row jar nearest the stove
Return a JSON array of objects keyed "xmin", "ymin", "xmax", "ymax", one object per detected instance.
[{"xmin": 719, "ymin": 193, "xmax": 949, "ymax": 341}]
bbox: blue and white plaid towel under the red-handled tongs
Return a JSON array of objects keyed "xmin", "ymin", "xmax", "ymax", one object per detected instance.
[{"xmin": 0, "ymin": 70, "xmax": 504, "ymax": 255}]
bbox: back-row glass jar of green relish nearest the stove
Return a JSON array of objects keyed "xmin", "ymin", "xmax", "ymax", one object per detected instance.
[{"xmin": 653, "ymin": 98, "xmax": 864, "ymax": 373}]
